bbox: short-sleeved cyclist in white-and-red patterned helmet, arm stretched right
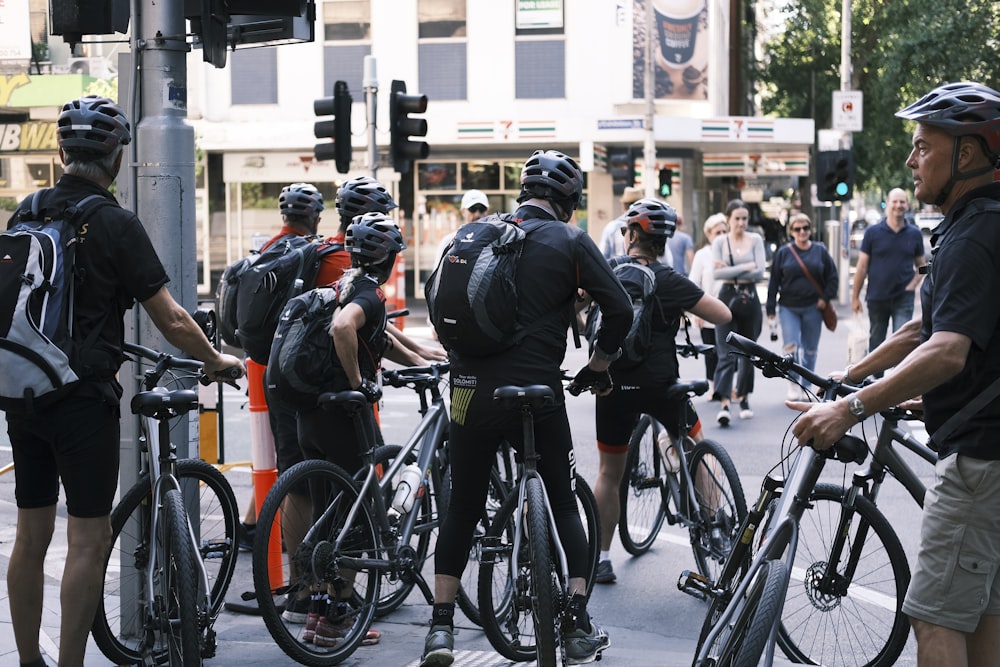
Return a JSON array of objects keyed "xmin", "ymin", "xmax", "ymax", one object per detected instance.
[{"xmin": 594, "ymin": 199, "xmax": 732, "ymax": 584}]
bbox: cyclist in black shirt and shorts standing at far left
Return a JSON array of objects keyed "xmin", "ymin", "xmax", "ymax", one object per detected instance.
[{"xmin": 5, "ymin": 96, "xmax": 242, "ymax": 667}]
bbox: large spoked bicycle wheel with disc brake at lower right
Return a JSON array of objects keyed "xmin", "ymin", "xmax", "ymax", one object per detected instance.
[{"xmin": 778, "ymin": 484, "xmax": 910, "ymax": 667}]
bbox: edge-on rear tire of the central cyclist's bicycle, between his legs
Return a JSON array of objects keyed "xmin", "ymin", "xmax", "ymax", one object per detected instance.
[{"xmin": 525, "ymin": 477, "xmax": 563, "ymax": 667}]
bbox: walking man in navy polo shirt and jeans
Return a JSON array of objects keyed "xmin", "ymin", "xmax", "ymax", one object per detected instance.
[{"xmin": 851, "ymin": 188, "xmax": 927, "ymax": 351}]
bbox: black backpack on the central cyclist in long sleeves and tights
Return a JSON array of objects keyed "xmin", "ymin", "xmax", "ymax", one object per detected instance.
[{"xmin": 424, "ymin": 215, "xmax": 544, "ymax": 357}]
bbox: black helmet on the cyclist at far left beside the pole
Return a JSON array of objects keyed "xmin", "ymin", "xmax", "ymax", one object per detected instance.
[{"xmin": 56, "ymin": 95, "xmax": 132, "ymax": 155}]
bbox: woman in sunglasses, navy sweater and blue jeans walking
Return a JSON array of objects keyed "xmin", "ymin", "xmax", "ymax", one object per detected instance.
[{"xmin": 766, "ymin": 213, "xmax": 838, "ymax": 401}]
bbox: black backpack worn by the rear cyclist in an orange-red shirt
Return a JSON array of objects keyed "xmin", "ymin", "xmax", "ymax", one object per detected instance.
[{"xmin": 220, "ymin": 234, "xmax": 343, "ymax": 364}]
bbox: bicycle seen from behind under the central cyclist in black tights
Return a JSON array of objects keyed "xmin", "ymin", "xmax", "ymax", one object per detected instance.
[{"xmin": 479, "ymin": 385, "xmax": 610, "ymax": 666}]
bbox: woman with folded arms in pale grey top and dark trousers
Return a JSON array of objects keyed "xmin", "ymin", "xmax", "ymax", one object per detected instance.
[{"xmin": 712, "ymin": 199, "xmax": 766, "ymax": 426}]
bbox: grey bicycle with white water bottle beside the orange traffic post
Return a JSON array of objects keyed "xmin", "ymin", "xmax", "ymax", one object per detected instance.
[{"xmin": 253, "ymin": 364, "xmax": 448, "ymax": 665}]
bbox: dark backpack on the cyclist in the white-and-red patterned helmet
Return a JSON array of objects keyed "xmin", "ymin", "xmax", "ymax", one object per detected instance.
[{"xmin": 586, "ymin": 256, "xmax": 659, "ymax": 368}]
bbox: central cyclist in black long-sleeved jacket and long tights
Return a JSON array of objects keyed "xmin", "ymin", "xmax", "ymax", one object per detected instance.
[{"xmin": 421, "ymin": 151, "xmax": 632, "ymax": 666}]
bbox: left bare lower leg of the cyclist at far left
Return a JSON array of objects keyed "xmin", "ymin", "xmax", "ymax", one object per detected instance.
[{"xmin": 7, "ymin": 505, "xmax": 56, "ymax": 662}]
